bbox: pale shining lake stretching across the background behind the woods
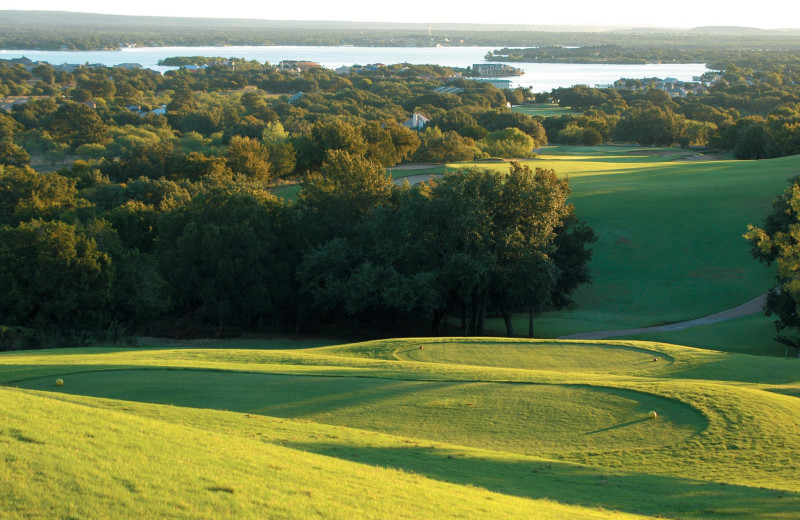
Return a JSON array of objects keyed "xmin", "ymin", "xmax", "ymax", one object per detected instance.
[{"xmin": 0, "ymin": 46, "xmax": 708, "ymax": 92}]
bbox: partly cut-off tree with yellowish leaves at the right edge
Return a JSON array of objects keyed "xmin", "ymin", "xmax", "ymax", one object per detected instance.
[{"xmin": 744, "ymin": 177, "xmax": 800, "ymax": 356}]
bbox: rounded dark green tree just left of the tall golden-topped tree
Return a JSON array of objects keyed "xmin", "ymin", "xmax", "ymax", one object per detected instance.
[{"xmin": 156, "ymin": 183, "xmax": 297, "ymax": 331}]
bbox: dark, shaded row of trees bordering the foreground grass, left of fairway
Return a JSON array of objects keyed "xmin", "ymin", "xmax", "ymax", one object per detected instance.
[{"xmin": 0, "ymin": 155, "xmax": 594, "ymax": 348}]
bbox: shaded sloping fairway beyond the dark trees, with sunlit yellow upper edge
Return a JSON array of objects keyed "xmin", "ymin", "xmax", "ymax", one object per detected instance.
[{"xmin": 446, "ymin": 146, "xmax": 800, "ymax": 342}]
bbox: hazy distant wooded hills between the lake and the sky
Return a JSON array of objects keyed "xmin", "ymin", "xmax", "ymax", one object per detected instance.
[{"xmin": 0, "ymin": 11, "xmax": 800, "ymax": 50}]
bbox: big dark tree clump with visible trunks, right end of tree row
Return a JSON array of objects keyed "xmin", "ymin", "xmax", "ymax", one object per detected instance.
[{"xmin": 298, "ymin": 163, "xmax": 594, "ymax": 335}]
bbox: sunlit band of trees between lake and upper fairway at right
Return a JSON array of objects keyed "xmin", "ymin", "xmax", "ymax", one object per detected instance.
[{"xmin": 539, "ymin": 65, "xmax": 800, "ymax": 159}]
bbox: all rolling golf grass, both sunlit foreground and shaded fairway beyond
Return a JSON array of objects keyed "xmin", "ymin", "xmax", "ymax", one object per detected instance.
[{"xmin": 0, "ymin": 146, "xmax": 800, "ymax": 519}]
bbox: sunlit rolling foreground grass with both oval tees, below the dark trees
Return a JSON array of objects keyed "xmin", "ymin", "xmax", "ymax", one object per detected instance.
[{"xmin": 0, "ymin": 338, "xmax": 800, "ymax": 519}]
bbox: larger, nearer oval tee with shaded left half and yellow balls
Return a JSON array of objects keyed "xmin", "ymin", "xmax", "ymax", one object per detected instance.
[{"xmin": 20, "ymin": 369, "xmax": 707, "ymax": 455}]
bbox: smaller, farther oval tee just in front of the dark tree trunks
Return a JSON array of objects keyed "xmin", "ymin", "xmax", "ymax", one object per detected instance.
[{"xmin": 395, "ymin": 342, "xmax": 673, "ymax": 373}]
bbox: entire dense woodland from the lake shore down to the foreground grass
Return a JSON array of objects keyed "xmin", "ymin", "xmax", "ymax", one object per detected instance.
[{"xmin": 0, "ymin": 45, "xmax": 800, "ymax": 348}]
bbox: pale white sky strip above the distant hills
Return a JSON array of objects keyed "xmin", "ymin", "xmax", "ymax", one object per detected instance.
[{"xmin": 9, "ymin": 0, "xmax": 800, "ymax": 29}]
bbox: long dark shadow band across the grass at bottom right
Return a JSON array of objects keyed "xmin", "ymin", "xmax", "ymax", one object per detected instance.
[{"xmin": 284, "ymin": 440, "xmax": 800, "ymax": 519}]
